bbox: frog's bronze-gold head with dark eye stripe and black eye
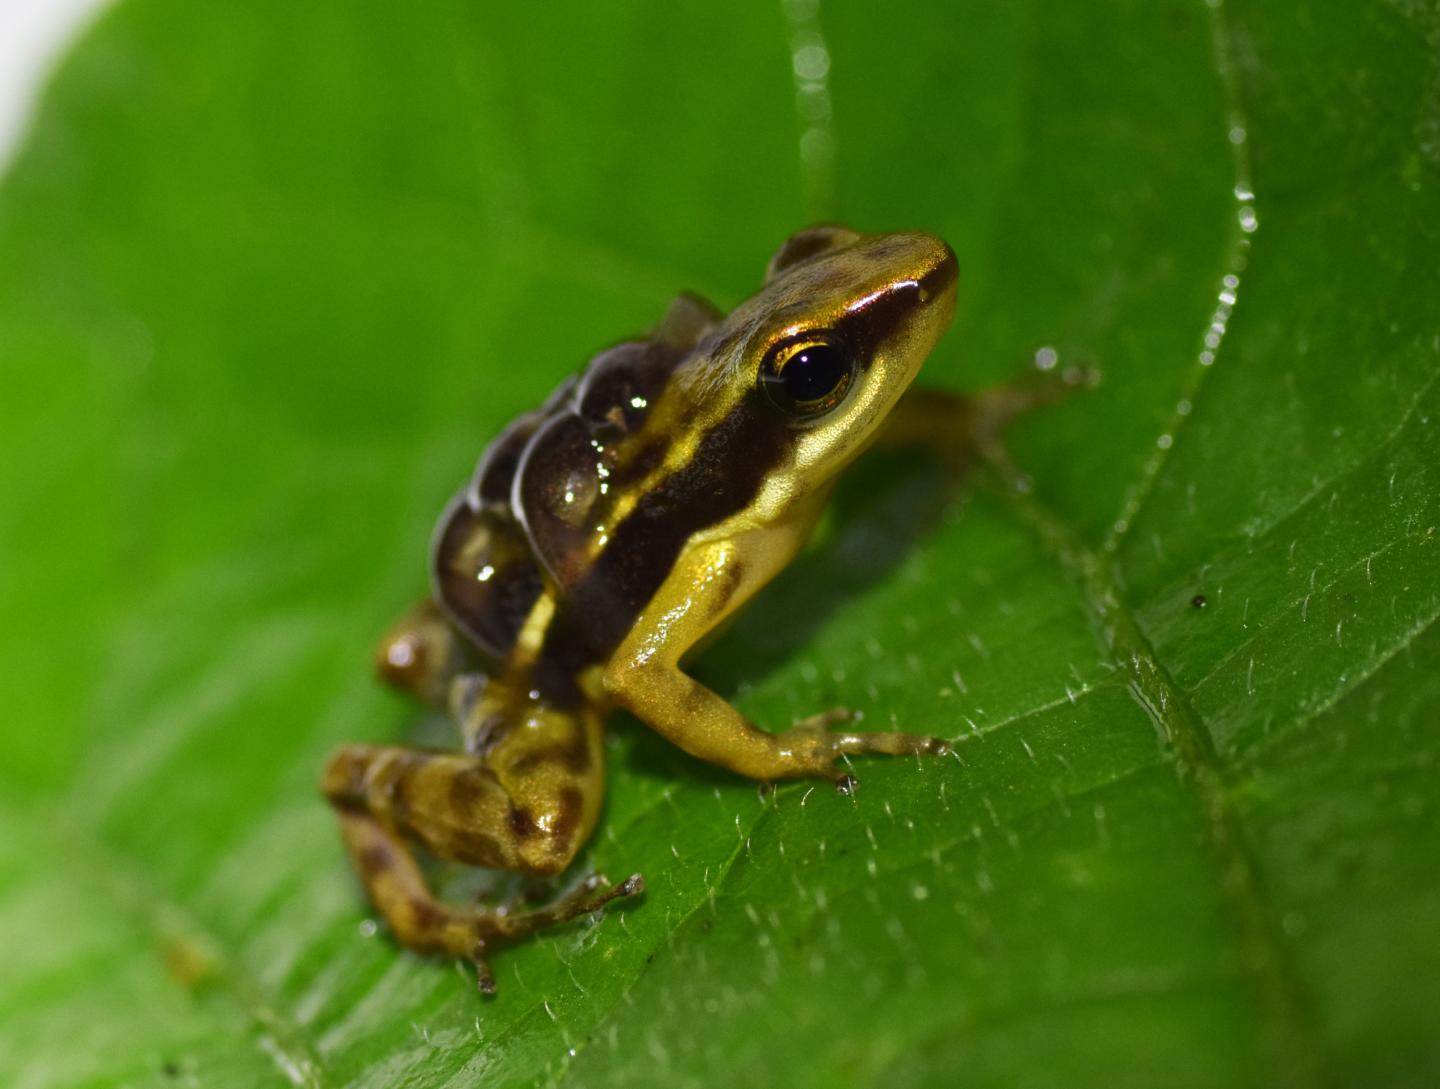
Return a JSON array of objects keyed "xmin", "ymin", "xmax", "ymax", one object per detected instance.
[{"xmin": 685, "ymin": 228, "xmax": 958, "ymax": 503}]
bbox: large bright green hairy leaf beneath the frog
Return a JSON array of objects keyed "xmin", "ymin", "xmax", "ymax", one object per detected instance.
[{"xmin": 0, "ymin": 0, "xmax": 1440, "ymax": 1089}]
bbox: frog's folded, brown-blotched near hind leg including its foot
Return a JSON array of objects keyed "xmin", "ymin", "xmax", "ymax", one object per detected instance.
[{"xmin": 324, "ymin": 686, "xmax": 642, "ymax": 988}]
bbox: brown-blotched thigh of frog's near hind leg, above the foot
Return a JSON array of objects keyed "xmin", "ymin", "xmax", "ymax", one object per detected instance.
[{"xmin": 324, "ymin": 712, "xmax": 603, "ymax": 874}]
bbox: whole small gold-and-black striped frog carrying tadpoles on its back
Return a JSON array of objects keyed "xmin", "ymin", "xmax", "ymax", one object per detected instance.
[{"xmin": 321, "ymin": 225, "xmax": 1048, "ymax": 994}]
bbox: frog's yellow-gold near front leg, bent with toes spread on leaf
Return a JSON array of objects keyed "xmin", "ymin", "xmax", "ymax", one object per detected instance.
[{"xmin": 605, "ymin": 543, "xmax": 949, "ymax": 779}]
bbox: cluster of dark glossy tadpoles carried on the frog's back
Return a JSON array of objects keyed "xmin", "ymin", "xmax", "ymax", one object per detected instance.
[{"xmin": 432, "ymin": 297, "xmax": 713, "ymax": 671}]
